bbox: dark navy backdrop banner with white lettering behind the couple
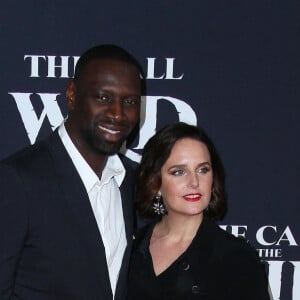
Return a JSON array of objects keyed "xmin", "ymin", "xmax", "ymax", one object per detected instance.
[{"xmin": 0, "ymin": 0, "xmax": 300, "ymax": 300}]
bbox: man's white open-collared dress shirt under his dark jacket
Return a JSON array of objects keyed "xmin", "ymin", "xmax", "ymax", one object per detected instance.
[{"xmin": 58, "ymin": 124, "xmax": 127, "ymax": 295}]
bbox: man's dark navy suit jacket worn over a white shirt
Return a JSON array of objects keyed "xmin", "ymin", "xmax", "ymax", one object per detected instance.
[{"xmin": 0, "ymin": 132, "xmax": 134, "ymax": 300}]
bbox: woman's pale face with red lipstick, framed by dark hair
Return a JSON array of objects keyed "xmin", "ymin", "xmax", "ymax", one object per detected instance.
[{"xmin": 160, "ymin": 138, "xmax": 213, "ymax": 218}]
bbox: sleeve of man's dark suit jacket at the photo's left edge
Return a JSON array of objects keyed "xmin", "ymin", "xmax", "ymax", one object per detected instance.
[{"xmin": 0, "ymin": 164, "xmax": 27, "ymax": 300}]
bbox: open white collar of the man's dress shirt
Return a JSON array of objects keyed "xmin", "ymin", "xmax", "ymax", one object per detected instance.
[{"xmin": 58, "ymin": 123, "xmax": 125, "ymax": 192}]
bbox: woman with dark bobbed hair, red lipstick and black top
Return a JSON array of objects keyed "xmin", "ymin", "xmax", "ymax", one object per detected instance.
[{"xmin": 127, "ymin": 123, "xmax": 269, "ymax": 300}]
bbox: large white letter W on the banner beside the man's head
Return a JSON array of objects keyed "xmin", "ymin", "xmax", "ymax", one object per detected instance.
[{"xmin": 8, "ymin": 93, "xmax": 63, "ymax": 144}]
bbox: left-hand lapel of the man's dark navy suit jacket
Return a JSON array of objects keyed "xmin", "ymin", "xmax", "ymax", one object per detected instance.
[{"xmin": 45, "ymin": 131, "xmax": 111, "ymax": 294}]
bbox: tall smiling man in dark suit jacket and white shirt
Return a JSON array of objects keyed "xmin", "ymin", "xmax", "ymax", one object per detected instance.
[{"xmin": 0, "ymin": 45, "xmax": 142, "ymax": 300}]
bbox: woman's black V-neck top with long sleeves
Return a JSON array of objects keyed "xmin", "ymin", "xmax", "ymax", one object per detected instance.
[{"xmin": 127, "ymin": 219, "xmax": 270, "ymax": 300}]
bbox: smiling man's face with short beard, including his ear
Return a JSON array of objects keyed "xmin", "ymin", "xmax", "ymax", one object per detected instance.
[{"xmin": 67, "ymin": 59, "xmax": 141, "ymax": 155}]
